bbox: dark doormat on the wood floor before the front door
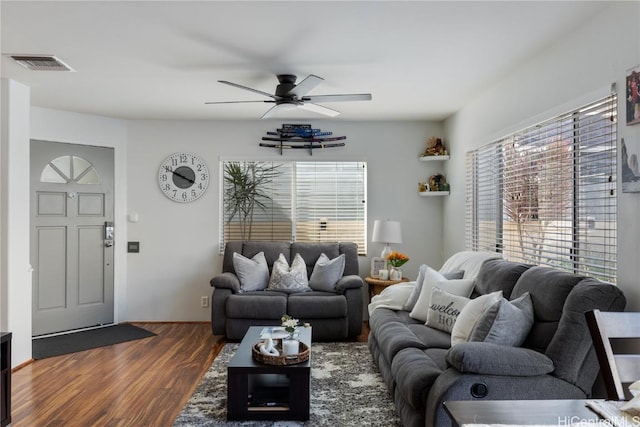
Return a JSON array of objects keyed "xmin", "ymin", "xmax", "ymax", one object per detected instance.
[{"xmin": 32, "ymin": 323, "xmax": 156, "ymax": 360}]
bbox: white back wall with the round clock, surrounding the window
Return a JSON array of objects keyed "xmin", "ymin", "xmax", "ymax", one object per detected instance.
[{"xmin": 126, "ymin": 120, "xmax": 442, "ymax": 320}]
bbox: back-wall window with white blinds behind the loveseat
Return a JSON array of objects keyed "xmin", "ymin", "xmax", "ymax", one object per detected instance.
[{"xmin": 220, "ymin": 161, "xmax": 367, "ymax": 255}]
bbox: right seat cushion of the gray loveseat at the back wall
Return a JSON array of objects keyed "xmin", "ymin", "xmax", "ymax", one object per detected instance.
[{"xmin": 287, "ymin": 291, "xmax": 347, "ymax": 319}]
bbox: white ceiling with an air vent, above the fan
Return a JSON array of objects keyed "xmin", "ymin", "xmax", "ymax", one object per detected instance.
[{"xmin": 0, "ymin": 0, "xmax": 607, "ymax": 120}]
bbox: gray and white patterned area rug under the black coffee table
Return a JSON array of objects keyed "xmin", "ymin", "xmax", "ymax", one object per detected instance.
[{"xmin": 173, "ymin": 342, "xmax": 401, "ymax": 427}]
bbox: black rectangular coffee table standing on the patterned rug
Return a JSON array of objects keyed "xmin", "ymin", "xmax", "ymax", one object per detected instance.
[{"xmin": 227, "ymin": 326, "xmax": 311, "ymax": 421}]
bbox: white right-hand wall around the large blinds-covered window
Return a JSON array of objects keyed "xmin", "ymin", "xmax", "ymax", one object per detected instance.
[{"xmin": 444, "ymin": 2, "xmax": 640, "ymax": 310}]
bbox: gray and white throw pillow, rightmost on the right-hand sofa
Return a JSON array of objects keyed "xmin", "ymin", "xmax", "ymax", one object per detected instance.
[{"xmin": 469, "ymin": 292, "xmax": 533, "ymax": 347}]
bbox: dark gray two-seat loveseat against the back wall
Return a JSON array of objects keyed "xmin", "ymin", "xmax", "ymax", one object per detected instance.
[{"xmin": 211, "ymin": 242, "xmax": 364, "ymax": 341}]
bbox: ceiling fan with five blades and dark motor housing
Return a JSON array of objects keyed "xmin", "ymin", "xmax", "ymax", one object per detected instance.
[{"xmin": 205, "ymin": 74, "xmax": 371, "ymax": 119}]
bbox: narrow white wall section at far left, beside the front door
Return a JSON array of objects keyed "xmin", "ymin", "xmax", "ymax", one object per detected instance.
[{"xmin": 0, "ymin": 79, "xmax": 31, "ymax": 367}]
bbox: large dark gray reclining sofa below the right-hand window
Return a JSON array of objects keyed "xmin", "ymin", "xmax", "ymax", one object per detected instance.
[{"xmin": 369, "ymin": 254, "xmax": 626, "ymax": 427}]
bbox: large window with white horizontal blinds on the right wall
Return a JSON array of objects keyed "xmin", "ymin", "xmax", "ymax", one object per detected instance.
[{"xmin": 465, "ymin": 95, "xmax": 617, "ymax": 283}]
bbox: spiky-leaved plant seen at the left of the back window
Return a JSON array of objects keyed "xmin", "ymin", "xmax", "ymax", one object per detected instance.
[{"xmin": 224, "ymin": 162, "xmax": 281, "ymax": 240}]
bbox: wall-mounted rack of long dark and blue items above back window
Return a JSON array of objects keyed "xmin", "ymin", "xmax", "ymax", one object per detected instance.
[{"xmin": 260, "ymin": 124, "xmax": 347, "ymax": 155}]
